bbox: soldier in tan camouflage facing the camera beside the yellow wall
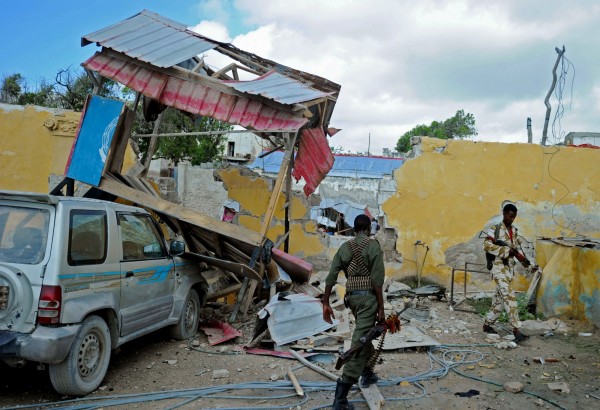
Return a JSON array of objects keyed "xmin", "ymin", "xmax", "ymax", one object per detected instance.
[{"xmin": 483, "ymin": 204, "xmax": 528, "ymax": 342}]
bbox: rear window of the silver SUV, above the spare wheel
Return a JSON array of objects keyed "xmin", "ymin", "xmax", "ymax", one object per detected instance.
[{"xmin": 0, "ymin": 205, "xmax": 50, "ymax": 265}]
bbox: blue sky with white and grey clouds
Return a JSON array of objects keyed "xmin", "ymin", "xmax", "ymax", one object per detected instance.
[{"xmin": 0, "ymin": 0, "xmax": 600, "ymax": 155}]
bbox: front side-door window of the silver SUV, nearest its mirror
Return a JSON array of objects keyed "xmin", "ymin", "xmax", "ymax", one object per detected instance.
[{"xmin": 118, "ymin": 213, "xmax": 167, "ymax": 261}]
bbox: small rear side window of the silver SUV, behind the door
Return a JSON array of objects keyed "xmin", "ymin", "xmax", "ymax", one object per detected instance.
[{"xmin": 67, "ymin": 210, "xmax": 108, "ymax": 265}]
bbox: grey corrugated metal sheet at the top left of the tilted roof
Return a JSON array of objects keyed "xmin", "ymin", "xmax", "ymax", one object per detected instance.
[{"xmin": 81, "ymin": 10, "xmax": 218, "ymax": 68}]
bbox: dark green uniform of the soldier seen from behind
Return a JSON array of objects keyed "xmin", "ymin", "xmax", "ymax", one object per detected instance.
[{"xmin": 325, "ymin": 233, "xmax": 385, "ymax": 383}]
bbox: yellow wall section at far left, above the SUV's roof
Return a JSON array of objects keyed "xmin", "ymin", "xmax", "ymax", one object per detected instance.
[{"xmin": 0, "ymin": 104, "xmax": 135, "ymax": 193}]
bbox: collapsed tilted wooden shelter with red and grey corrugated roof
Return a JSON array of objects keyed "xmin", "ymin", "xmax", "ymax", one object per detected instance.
[{"xmin": 52, "ymin": 10, "xmax": 341, "ymax": 318}]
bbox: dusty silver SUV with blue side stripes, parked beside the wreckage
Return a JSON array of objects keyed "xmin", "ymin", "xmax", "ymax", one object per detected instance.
[{"xmin": 0, "ymin": 191, "xmax": 207, "ymax": 395}]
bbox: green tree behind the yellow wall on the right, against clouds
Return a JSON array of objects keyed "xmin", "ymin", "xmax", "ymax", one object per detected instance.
[{"xmin": 396, "ymin": 110, "xmax": 477, "ymax": 152}]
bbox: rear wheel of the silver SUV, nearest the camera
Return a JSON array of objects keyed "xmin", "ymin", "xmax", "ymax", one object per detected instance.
[{"xmin": 49, "ymin": 316, "xmax": 111, "ymax": 396}]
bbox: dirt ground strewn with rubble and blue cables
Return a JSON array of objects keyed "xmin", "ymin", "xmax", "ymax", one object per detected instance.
[{"xmin": 0, "ymin": 299, "xmax": 600, "ymax": 409}]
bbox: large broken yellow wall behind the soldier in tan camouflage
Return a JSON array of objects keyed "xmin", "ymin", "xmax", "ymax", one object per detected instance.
[{"xmin": 383, "ymin": 138, "xmax": 600, "ymax": 288}]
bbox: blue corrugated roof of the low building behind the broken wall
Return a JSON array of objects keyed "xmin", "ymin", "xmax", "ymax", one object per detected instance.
[{"xmin": 248, "ymin": 151, "xmax": 404, "ymax": 178}]
